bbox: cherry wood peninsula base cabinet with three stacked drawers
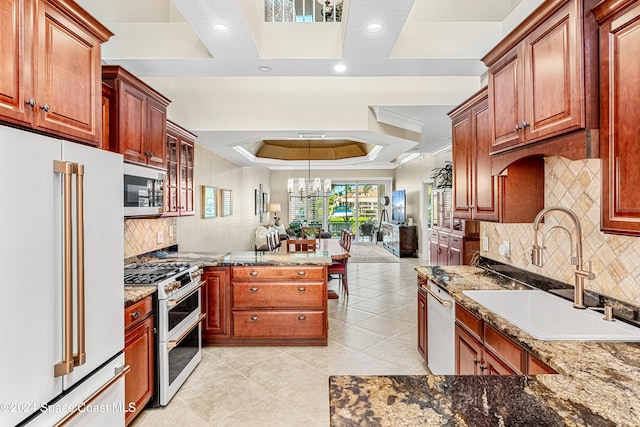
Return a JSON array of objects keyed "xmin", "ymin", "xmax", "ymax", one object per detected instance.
[{"xmin": 202, "ymin": 266, "xmax": 328, "ymax": 346}]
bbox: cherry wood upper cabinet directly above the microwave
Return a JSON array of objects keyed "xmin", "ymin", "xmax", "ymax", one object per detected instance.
[{"xmin": 102, "ymin": 65, "xmax": 171, "ymax": 169}]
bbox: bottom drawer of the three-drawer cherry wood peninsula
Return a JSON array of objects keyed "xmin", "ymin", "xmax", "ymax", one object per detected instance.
[{"xmin": 233, "ymin": 310, "xmax": 325, "ymax": 338}]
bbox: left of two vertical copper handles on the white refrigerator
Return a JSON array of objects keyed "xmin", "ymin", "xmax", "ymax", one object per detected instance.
[{"xmin": 53, "ymin": 160, "xmax": 73, "ymax": 377}]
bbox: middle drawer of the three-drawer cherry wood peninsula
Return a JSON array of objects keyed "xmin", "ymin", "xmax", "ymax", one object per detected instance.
[{"xmin": 233, "ymin": 282, "xmax": 327, "ymax": 309}]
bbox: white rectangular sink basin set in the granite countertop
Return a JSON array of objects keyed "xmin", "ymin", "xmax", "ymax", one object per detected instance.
[{"xmin": 463, "ymin": 290, "xmax": 640, "ymax": 341}]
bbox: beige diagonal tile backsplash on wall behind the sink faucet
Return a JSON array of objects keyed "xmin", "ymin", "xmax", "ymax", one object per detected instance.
[{"xmin": 480, "ymin": 156, "xmax": 640, "ymax": 305}]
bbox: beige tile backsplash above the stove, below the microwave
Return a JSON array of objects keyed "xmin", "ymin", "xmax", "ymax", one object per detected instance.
[{"xmin": 124, "ymin": 218, "xmax": 178, "ymax": 259}]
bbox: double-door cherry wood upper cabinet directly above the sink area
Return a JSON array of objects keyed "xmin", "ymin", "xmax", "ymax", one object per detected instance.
[{"xmin": 483, "ymin": 0, "xmax": 598, "ymax": 162}]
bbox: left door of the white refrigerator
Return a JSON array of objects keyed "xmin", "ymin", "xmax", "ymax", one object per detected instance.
[{"xmin": 0, "ymin": 126, "xmax": 62, "ymax": 425}]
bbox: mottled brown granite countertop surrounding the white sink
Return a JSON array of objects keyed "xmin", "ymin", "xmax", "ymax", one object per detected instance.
[{"xmin": 329, "ymin": 266, "xmax": 640, "ymax": 426}]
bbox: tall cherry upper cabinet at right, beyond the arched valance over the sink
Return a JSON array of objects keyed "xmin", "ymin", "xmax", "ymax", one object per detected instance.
[{"xmin": 449, "ymin": 89, "xmax": 544, "ymax": 224}]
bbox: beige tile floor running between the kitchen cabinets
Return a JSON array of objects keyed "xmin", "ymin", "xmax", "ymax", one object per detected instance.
[{"xmin": 133, "ymin": 258, "xmax": 427, "ymax": 427}]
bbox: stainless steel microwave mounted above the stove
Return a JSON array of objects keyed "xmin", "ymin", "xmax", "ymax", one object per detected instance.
[{"xmin": 124, "ymin": 163, "xmax": 167, "ymax": 217}]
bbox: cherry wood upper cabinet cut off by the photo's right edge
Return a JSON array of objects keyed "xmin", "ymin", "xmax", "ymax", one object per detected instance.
[{"xmin": 593, "ymin": 0, "xmax": 640, "ymax": 235}]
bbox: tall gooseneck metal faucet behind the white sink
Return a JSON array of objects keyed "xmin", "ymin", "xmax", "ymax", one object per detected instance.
[{"xmin": 531, "ymin": 206, "xmax": 596, "ymax": 308}]
